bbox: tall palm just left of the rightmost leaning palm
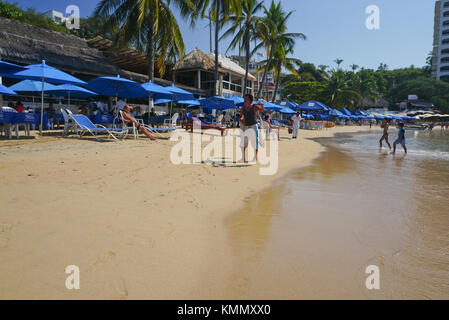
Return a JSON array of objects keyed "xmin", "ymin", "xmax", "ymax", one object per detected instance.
[{"xmin": 220, "ymin": 0, "xmax": 263, "ymax": 94}]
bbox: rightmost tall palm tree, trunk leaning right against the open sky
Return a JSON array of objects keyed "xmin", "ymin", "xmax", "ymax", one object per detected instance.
[{"xmin": 253, "ymin": 0, "xmax": 306, "ymax": 97}]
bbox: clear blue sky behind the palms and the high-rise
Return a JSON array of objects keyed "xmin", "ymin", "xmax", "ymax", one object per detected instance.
[{"xmin": 9, "ymin": 0, "xmax": 435, "ymax": 69}]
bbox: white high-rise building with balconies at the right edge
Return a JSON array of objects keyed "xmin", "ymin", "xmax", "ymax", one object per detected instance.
[{"xmin": 432, "ymin": 0, "xmax": 449, "ymax": 80}]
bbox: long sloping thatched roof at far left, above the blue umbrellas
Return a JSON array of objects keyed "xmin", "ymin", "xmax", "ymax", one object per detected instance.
[{"xmin": 0, "ymin": 17, "xmax": 121, "ymax": 76}]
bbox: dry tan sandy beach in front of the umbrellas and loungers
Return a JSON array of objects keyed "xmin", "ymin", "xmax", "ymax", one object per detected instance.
[{"xmin": 0, "ymin": 126, "xmax": 378, "ymax": 299}]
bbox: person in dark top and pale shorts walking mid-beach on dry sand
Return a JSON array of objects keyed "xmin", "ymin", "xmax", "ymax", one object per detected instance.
[{"xmin": 240, "ymin": 94, "xmax": 265, "ymax": 162}]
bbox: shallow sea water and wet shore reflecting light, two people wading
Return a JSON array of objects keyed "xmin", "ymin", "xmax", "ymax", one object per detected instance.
[{"xmin": 228, "ymin": 128, "xmax": 449, "ymax": 299}]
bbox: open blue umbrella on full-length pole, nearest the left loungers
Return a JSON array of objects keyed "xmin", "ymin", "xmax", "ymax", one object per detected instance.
[{"xmin": 7, "ymin": 60, "xmax": 86, "ymax": 135}]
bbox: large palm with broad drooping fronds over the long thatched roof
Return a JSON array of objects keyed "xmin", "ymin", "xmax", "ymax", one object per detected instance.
[{"xmin": 94, "ymin": 0, "xmax": 196, "ymax": 81}]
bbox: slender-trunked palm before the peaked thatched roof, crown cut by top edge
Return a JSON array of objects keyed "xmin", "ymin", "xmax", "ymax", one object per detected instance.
[{"xmin": 191, "ymin": 0, "xmax": 241, "ymax": 95}]
